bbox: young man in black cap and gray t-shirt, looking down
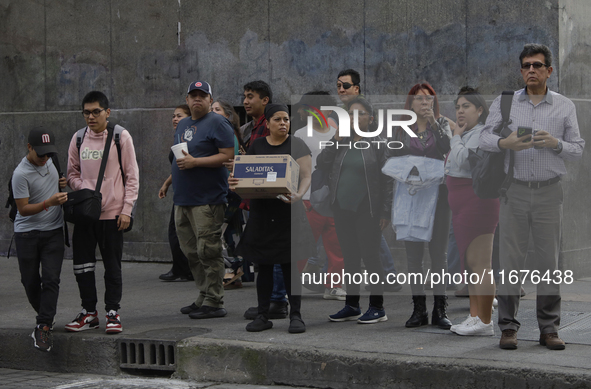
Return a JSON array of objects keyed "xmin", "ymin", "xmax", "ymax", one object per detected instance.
[{"xmin": 12, "ymin": 128, "xmax": 68, "ymax": 351}]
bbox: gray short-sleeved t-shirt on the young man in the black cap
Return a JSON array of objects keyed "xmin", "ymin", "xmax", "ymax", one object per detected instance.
[{"xmin": 12, "ymin": 157, "xmax": 64, "ymax": 232}]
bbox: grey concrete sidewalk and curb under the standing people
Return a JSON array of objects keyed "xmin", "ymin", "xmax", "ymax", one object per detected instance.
[{"xmin": 0, "ymin": 258, "xmax": 591, "ymax": 388}]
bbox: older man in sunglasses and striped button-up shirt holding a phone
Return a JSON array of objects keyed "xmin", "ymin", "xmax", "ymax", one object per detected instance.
[{"xmin": 480, "ymin": 44, "xmax": 585, "ymax": 350}]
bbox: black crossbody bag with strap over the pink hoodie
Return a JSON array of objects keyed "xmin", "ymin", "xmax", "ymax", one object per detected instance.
[{"xmin": 63, "ymin": 127, "xmax": 114, "ymax": 224}]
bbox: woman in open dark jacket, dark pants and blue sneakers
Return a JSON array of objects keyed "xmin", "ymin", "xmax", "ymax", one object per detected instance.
[{"xmin": 316, "ymin": 97, "xmax": 393, "ymax": 324}]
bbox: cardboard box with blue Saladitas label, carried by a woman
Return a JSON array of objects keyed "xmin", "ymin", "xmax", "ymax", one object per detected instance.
[{"xmin": 234, "ymin": 154, "xmax": 300, "ymax": 199}]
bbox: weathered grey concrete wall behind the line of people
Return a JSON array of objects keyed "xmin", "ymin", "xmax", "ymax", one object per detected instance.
[{"xmin": 0, "ymin": 0, "xmax": 591, "ymax": 276}]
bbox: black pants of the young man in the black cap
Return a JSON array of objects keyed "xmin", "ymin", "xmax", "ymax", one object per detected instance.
[{"xmin": 14, "ymin": 228, "xmax": 64, "ymax": 327}]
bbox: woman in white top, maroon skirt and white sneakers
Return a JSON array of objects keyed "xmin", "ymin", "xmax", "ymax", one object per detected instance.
[{"xmin": 445, "ymin": 87, "xmax": 499, "ymax": 336}]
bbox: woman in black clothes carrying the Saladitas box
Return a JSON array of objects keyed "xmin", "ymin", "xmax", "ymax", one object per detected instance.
[{"xmin": 228, "ymin": 104, "xmax": 315, "ymax": 333}]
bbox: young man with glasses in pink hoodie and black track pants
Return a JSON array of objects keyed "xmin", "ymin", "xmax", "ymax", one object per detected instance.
[{"xmin": 66, "ymin": 91, "xmax": 139, "ymax": 334}]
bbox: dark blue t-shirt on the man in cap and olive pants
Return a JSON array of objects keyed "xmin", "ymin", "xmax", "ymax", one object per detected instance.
[{"xmin": 172, "ymin": 112, "xmax": 234, "ymax": 206}]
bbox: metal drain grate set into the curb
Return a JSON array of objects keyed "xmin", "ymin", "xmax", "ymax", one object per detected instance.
[{"xmin": 118, "ymin": 339, "xmax": 176, "ymax": 371}]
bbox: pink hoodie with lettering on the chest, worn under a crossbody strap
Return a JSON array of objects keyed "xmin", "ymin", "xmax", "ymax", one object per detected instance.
[{"xmin": 68, "ymin": 127, "xmax": 140, "ymax": 220}]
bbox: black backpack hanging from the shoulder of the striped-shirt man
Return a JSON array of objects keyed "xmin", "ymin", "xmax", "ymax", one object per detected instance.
[{"xmin": 468, "ymin": 91, "xmax": 515, "ymax": 202}]
